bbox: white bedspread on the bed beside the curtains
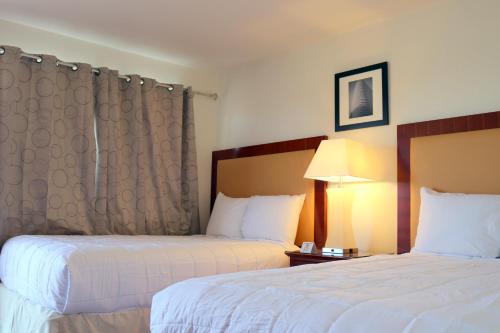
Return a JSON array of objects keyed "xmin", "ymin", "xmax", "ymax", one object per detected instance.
[{"xmin": 0, "ymin": 236, "xmax": 288, "ymax": 314}]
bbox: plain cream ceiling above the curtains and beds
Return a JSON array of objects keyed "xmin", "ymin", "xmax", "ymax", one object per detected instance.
[{"xmin": 0, "ymin": 0, "xmax": 436, "ymax": 67}]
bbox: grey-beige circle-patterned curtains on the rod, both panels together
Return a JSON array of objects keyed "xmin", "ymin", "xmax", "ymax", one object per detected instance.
[{"xmin": 0, "ymin": 47, "xmax": 199, "ymax": 245}]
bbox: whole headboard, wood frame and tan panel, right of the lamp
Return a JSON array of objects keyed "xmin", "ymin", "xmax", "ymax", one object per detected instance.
[{"xmin": 397, "ymin": 111, "xmax": 500, "ymax": 253}]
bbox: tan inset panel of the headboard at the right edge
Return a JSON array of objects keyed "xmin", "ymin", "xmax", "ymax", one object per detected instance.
[{"xmin": 410, "ymin": 128, "xmax": 500, "ymax": 246}]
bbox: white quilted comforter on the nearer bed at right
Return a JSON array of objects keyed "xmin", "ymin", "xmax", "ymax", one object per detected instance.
[{"xmin": 151, "ymin": 254, "xmax": 500, "ymax": 333}]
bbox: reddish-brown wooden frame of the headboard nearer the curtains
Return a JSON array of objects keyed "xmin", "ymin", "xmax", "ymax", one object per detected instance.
[{"xmin": 210, "ymin": 136, "xmax": 328, "ymax": 247}]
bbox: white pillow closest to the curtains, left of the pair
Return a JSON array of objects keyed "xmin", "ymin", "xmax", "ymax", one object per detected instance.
[{"xmin": 207, "ymin": 192, "xmax": 250, "ymax": 238}]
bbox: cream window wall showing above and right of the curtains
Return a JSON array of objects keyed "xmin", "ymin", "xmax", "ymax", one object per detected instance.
[{"xmin": 0, "ymin": 20, "xmax": 223, "ymax": 230}]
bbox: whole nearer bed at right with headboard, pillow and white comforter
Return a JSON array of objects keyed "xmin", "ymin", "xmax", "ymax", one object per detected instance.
[{"xmin": 151, "ymin": 112, "xmax": 500, "ymax": 333}]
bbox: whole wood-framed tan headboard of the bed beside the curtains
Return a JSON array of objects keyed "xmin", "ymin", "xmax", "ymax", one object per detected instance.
[{"xmin": 210, "ymin": 136, "xmax": 328, "ymax": 247}]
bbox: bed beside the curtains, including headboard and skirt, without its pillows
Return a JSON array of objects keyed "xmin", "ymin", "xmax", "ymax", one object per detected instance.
[{"xmin": 0, "ymin": 137, "xmax": 325, "ymax": 333}]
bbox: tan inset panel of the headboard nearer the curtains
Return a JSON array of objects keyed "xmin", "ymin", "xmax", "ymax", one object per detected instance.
[{"xmin": 217, "ymin": 149, "xmax": 314, "ymax": 244}]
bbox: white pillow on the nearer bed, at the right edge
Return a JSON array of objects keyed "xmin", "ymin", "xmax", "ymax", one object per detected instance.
[{"xmin": 413, "ymin": 187, "xmax": 500, "ymax": 258}]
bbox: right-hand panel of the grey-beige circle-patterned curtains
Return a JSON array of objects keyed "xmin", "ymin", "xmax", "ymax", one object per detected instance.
[{"xmin": 96, "ymin": 68, "xmax": 199, "ymax": 234}]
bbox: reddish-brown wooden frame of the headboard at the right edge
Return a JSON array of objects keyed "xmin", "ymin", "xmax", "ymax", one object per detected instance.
[{"xmin": 397, "ymin": 111, "xmax": 500, "ymax": 253}]
